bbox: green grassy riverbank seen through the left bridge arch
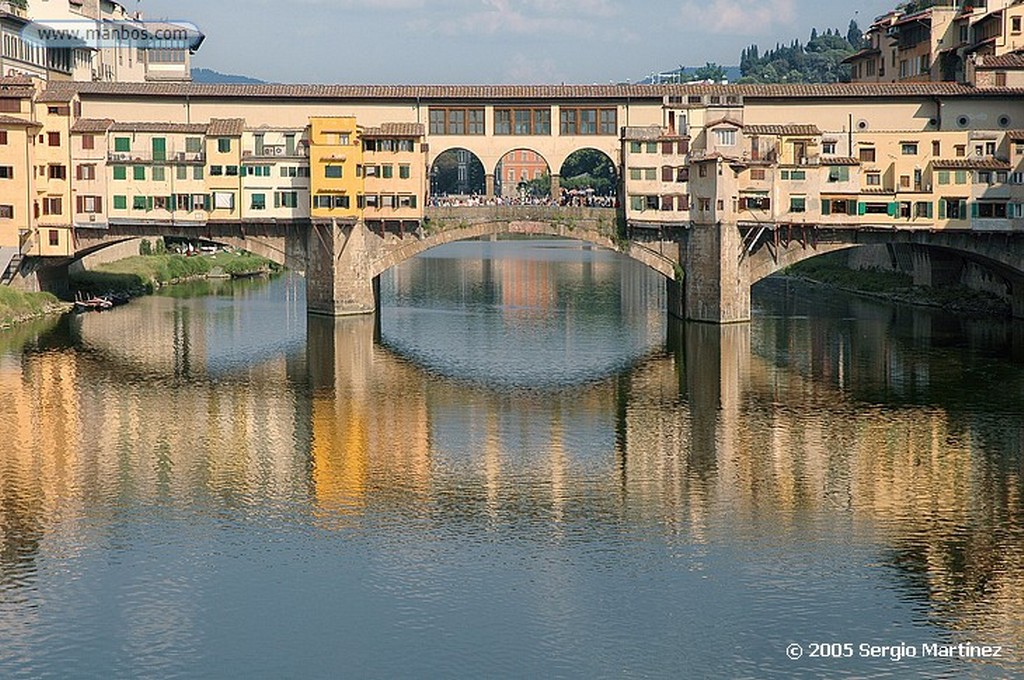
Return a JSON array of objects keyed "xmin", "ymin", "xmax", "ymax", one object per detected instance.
[{"xmin": 71, "ymin": 252, "xmax": 276, "ymax": 295}]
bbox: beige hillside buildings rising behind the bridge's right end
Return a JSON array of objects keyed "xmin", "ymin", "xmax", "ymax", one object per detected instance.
[{"xmin": 844, "ymin": 0, "xmax": 1024, "ymax": 87}]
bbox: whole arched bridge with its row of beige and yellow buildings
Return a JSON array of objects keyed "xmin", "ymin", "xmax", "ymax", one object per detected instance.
[{"xmin": 0, "ymin": 79, "xmax": 1024, "ymax": 321}]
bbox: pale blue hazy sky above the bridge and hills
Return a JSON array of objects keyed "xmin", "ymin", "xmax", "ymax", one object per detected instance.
[{"xmin": 134, "ymin": 0, "xmax": 895, "ymax": 84}]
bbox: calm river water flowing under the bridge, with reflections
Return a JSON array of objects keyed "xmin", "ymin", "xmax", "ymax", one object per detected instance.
[{"xmin": 0, "ymin": 241, "xmax": 1024, "ymax": 678}]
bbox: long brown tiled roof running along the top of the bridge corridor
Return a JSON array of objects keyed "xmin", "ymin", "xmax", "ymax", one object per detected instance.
[{"xmin": 34, "ymin": 81, "xmax": 1024, "ymax": 101}]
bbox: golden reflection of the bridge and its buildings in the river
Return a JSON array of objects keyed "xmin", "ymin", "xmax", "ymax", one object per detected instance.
[{"xmin": 0, "ymin": 267, "xmax": 1024, "ymax": 667}]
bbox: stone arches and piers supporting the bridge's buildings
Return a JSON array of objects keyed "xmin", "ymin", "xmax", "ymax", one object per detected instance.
[{"xmin": 77, "ymin": 206, "xmax": 1024, "ymax": 324}]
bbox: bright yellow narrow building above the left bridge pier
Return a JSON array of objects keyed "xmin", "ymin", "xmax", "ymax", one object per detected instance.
[{"xmin": 309, "ymin": 116, "xmax": 362, "ymax": 219}]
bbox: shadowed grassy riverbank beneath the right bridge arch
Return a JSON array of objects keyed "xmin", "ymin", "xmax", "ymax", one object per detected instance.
[{"xmin": 783, "ymin": 255, "xmax": 1011, "ymax": 316}]
